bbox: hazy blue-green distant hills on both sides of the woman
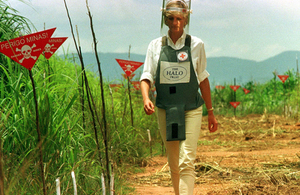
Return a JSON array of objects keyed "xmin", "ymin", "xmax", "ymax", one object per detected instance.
[{"xmin": 64, "ymin": 51, "xmax": 300, "ymax": 85}]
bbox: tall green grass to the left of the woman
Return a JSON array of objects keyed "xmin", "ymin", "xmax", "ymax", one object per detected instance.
[{"xmin": 0, "ymin": 50, "xmax": 156, "ymax": 194}]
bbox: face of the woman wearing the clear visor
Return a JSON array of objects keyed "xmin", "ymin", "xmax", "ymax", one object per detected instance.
[{"xmin": 166, "ymin": 14, "xmax": 186, "ymax": 33}]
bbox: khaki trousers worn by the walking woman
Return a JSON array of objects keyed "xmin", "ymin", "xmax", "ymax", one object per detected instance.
[{"xmin": 158, "ymin": 106, "xmax": 202, "ymax": 195}]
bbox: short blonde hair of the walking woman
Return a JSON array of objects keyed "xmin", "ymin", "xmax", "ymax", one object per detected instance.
[{"xmin": 163, "ymin": 0, "xmax": 189, "ymax": 25}]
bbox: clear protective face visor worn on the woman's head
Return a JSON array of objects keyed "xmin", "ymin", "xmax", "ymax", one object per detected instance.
[{"xmin": 160, "ymin": 0, "xmax": 192, "ymax": 36}]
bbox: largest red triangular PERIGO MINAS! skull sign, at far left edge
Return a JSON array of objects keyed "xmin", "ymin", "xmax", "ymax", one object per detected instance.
[{"xmin": 0, "ymin": 28, "xmax": 56, "ymax": 70}]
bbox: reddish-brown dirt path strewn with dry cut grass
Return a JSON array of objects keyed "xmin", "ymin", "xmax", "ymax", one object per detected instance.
[{"xmin": 130, "ymin": 116, "xmax": 300, "ymax": 195}]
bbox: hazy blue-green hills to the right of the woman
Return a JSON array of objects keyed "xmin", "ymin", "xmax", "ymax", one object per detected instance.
[{"xmin": 207, "ymin": 51, "xmax": 300, "ymax": 85}]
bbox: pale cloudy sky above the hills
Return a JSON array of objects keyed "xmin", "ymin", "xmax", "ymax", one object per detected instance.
[{"xmin": 7, "ymin": 0, "xmax": 300, "ymax": 61}]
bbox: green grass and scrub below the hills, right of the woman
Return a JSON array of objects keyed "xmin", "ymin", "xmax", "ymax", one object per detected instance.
[{"xmin": 212, "ymin": 69, "xmax": 300, "ymax": 119}]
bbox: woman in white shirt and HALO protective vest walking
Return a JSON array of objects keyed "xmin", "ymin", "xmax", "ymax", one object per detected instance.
[{"xmin": 140, "ymin": 0, "xmax": 218, "ymax": 195}]
